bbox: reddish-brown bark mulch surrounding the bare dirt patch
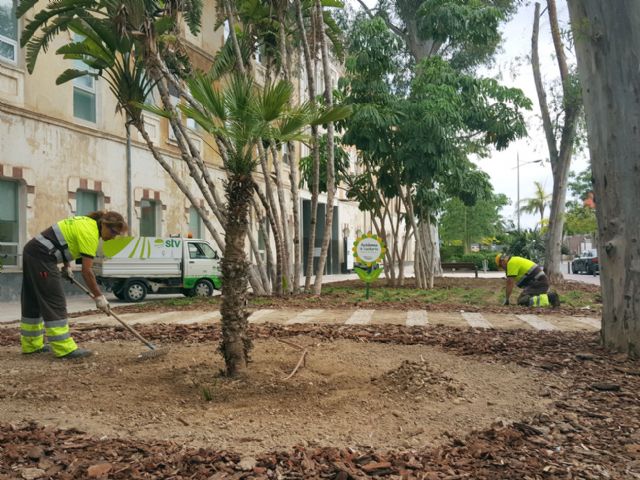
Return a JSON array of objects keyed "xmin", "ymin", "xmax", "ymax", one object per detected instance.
[{"xmin": 0, "ymin": 324, "xmax": 640, "ymax": 480}]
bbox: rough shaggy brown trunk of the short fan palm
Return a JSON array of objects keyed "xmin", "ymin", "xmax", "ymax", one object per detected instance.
[{"xmin": 220, "ymin": 175, "xmax": 254, "ymax": 377}]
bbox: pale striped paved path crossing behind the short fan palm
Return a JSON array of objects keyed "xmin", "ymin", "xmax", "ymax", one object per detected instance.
[{"xmin": 6, "ymin": 308, "xmax": 600, "ymax": 331}]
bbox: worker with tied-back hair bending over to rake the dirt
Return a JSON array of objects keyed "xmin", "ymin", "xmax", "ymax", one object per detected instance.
[{"xmin": 20, "ymin": 212, "xmax": 127, "ymax": 358}]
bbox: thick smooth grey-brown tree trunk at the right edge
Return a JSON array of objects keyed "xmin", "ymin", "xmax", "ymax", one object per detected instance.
[{"xmin": 569, "ymin": 0, "xmax": 640, "ymax": 358}]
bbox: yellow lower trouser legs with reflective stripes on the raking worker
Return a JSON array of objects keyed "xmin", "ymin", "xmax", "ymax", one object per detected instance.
[{"xmin": 20, "ymin": 317, "xmax": 78, "ymax": 357}]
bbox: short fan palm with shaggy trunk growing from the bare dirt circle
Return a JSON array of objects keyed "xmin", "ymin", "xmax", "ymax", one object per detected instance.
[{"xmin": 182, "ymin": 74, "xmax": 330, "ymax": 376}]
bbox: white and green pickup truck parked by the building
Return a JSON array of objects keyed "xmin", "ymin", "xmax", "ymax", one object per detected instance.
[{"xmin": 93, "ymin": 237, "xmax": 222, "ymax": 302}]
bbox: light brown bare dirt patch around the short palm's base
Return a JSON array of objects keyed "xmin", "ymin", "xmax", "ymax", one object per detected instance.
[{"xmin": 0, "ymin": 336, "xmax": 558, "ymax": 454}]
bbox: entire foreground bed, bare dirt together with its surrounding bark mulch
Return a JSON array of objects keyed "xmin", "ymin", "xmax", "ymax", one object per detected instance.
[{"xmin": 0, "ymin": 318, "xmax": 640, "ymax": 480}]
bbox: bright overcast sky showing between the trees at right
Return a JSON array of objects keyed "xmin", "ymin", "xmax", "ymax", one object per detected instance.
[{"xmin": 477, "ymin": 0, "xmax": 588, "ymax": 228}]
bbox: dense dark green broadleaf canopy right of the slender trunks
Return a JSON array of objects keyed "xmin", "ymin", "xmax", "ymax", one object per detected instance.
[{"xmin": 340, "ymin": 18, "xmax": 531, "ymax": 222}]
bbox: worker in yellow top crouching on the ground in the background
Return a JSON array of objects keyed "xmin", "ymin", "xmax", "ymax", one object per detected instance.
[{"xmin": 496, "ymin": 254, "xmax": 560, "ymax": 307}]
